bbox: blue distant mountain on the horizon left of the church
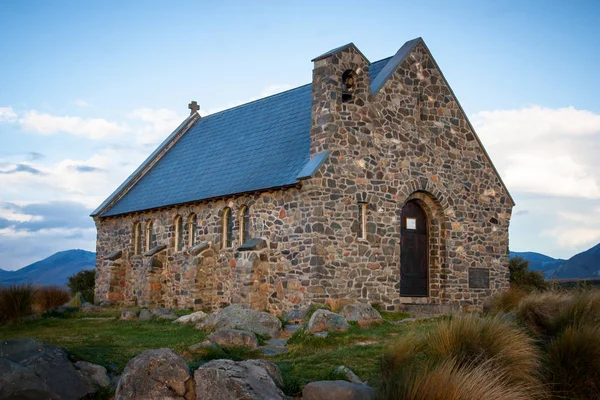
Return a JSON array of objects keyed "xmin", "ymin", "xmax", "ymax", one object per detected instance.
[{"xmin": 0, "ymin": 250, "xmax": 96, "ymax": 285}]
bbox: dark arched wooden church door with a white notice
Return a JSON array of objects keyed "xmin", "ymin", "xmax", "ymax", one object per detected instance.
[{"xmin": 400, "ymin": 200, "xmax": 429, "ymax": 297}]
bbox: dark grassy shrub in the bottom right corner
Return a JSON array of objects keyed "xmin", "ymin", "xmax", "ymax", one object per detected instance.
[{"xmin": 547, "ymin": 325, "xmax": 600, "ymax": 399}]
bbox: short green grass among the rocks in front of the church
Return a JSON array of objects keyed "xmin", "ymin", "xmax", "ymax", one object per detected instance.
[{"xmin": 0, "ymin": 311, "xmax": 433, "ymax": 394}]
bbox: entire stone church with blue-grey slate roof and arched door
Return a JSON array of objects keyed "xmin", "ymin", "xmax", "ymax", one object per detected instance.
[{"xmin": 92, "ymin": 38, "xmax": 514, "ymax": 313}]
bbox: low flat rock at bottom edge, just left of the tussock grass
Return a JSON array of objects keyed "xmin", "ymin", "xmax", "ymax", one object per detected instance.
[{"xmin": 302, "ymin": 381, "xmax": 375, "ymax": 400}]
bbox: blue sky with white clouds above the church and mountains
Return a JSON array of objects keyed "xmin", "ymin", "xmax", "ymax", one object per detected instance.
[{"xmin": 0, "ymin": 0, "xmax": 600, "ymax": 270}]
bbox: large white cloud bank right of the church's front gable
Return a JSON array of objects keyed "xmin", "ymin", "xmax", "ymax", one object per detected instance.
[{"xmin": 471, "ymin": 106, "xmax": 600, "ymax": 199}]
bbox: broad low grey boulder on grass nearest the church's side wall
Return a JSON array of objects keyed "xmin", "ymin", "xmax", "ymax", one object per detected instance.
[{"xmin": 196, "ymin": 304, "xmax": 281, "ymax": 337}]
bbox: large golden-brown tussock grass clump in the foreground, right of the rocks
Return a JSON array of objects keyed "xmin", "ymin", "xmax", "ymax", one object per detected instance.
[{"xmin": 381, "ymin": 316, "xmax": 542, "ymax": 399}]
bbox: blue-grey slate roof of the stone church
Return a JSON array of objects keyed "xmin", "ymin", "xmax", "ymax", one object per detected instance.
[{"xmin": 92, "ymin": 39, "xmax": 428, "ymax": 217}]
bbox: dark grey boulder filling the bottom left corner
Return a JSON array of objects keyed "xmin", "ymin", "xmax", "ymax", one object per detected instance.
[{"xmin": 0, "ymin": 339, "xmax": 96, "ymax": 400}]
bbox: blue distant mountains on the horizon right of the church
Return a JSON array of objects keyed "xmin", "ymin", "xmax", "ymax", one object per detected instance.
[{"xmin": 510, "ymin": 243, "xmax": 600, "ymax": 279}]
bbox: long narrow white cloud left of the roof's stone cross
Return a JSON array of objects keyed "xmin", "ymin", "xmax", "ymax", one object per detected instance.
[{"xmin": 19, "ymin": 110, "xmax": 128, "ymax": 140}]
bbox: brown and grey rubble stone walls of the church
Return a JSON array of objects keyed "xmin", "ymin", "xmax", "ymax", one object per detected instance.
[{"xmin": 95, "ymin": 42, "xmax": 513, "ymax": 313}]
